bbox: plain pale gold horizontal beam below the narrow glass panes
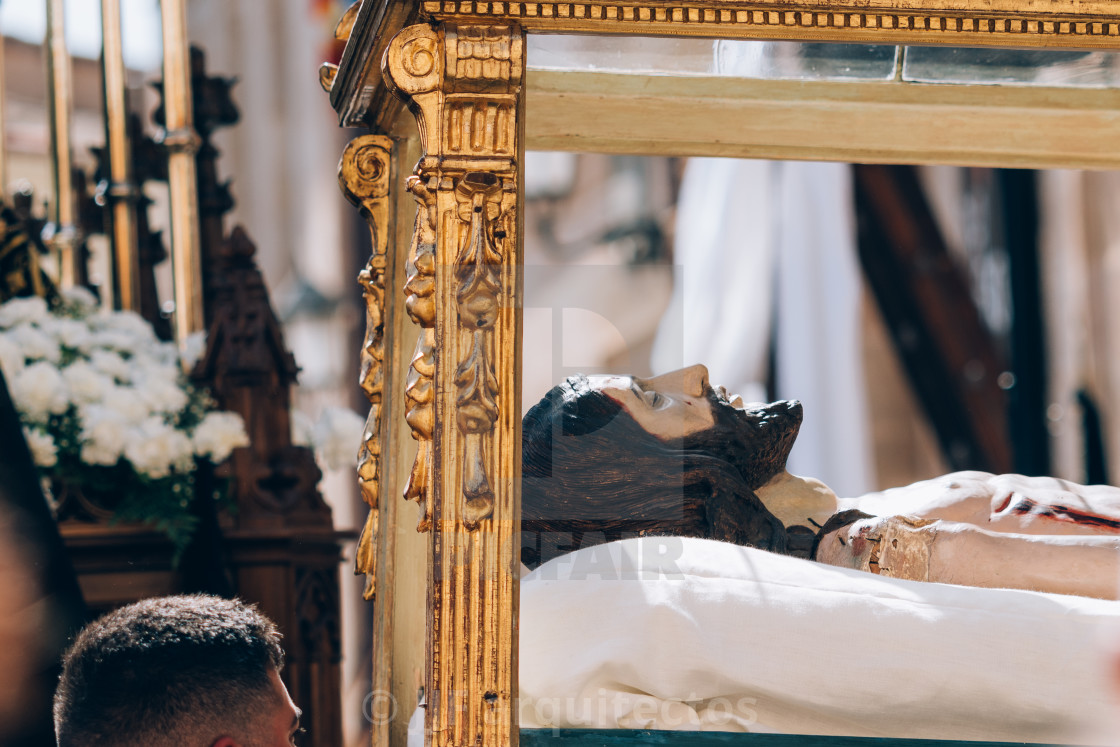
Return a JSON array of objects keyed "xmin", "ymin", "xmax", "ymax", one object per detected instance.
[{"xmin": 525, "ymin": 69, "xmax": 1120, "ymax": 169}]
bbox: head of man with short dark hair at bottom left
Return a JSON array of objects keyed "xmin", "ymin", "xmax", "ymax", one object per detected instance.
[{"xmin": 55, "ymin": 595, "xmax": 299, "ymax": 747}]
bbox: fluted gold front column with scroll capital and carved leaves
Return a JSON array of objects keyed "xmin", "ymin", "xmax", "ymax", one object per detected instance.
[{"xmin": 384, "ymin": 25, "xmax": 524, "ymax": 746}]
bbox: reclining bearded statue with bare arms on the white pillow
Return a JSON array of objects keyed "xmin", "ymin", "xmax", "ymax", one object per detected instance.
[{"xmin": 522, "ymin": 365, "xmax": 1120, "ymax": 599}]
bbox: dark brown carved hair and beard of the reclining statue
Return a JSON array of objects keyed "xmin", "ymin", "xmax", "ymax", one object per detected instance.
[{"xmin": 521, "ymin": 376, "xmax": 800, "ymax": 567}]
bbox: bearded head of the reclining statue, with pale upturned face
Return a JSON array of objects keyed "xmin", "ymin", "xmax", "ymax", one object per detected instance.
[{"xmin": 522, "ymin": 366, "xmax": 802, "ymax": 566}]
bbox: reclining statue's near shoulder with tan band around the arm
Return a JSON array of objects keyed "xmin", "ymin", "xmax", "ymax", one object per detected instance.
[{"xmin": 816, "ymin": 516, "xmax": 939, "ymax": 581}]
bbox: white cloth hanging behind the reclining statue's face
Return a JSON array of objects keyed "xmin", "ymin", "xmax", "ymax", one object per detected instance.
[{"xmin": 651, "ymin": 158, "xmax": 876, "ymax": 495}]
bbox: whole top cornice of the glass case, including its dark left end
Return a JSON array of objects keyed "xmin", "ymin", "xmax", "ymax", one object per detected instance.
[{"xmin": 324, "ymin": 0, "xmax": 1120, "ymax": 132}]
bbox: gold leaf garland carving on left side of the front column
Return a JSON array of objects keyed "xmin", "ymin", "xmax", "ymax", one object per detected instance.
[{"xmin": 404, "ymin": 176, "xmax": 436, "ymax": 532}]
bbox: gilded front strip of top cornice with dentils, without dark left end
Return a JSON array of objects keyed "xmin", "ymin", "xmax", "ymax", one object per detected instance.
[{"xmin": 421, "ymin": 0, "xmax": 1120, "ymax": 48}]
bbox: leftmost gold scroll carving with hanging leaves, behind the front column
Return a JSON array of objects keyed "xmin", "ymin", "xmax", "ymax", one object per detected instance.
[{"xmin": 338, "ymin": 134, "xmax": 392, "ymax": 599}]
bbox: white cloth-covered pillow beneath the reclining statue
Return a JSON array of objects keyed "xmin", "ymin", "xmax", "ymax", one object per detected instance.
[{"xmin": 520, "ymin": 538, "xmax": 1120, "ymax": 745}]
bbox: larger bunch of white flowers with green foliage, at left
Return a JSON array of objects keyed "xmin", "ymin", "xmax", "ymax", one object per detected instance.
[{"xmin": 0, "ymin": 289, "xmax": 249, "ymax": 552}]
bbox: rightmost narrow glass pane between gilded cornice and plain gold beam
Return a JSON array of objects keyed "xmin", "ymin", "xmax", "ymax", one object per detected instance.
[{"xmin": 903, "ymin": 47, "xmax": 1120, "ymax": 88}]
